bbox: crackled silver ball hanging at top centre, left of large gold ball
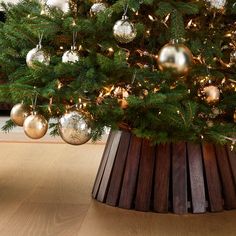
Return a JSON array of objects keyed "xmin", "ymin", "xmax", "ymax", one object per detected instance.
[{"xmin": 113, "ymin": 16, "xmax": 137, "ymax": 43}]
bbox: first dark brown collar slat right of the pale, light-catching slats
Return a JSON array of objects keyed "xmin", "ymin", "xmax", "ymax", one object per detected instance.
[{"xmin": 106, "ymin": 131, "xmax": 131, "ymax": 206}]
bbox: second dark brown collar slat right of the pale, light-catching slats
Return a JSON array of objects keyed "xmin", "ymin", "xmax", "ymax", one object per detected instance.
[{"xmin": 119, "ymin": 135, "xmax": 142, "ymax": 209}]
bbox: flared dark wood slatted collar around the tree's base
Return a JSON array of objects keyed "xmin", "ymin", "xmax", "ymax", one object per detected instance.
[{"xmin": 92, "ymin": 131, "xmax": 236, "ymax": 214}]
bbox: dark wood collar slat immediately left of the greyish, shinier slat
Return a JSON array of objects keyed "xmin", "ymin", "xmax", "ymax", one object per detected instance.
[{"xmin": 172, "ymin": 142, "xmax": 188, "ymax": 214}]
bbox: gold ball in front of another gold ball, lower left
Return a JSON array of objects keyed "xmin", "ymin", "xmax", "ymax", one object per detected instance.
[{"xmin": 23, "ymin": 112, "xmax": 48, "ymax": 139}]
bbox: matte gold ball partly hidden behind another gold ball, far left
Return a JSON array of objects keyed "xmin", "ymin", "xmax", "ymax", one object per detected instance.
[{"xmin": 10, "ymin": 103, "xmax": 31, "ymax": 126}]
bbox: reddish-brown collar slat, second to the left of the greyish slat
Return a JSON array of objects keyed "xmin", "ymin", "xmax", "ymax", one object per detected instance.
[{"xmin": 153, "ymin": 144, "xmax": 171, "ymax": 213}]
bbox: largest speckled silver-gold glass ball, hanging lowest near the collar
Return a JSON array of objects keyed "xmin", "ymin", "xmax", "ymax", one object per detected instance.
[{"xmin": 59, "ymin": 111, "xmax": 91, "ymax": 145}]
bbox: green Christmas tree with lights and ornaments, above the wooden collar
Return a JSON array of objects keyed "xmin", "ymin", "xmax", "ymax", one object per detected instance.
[{"xmin": 0, "ymin": 0, "xmax": 236, "ymax": 148}]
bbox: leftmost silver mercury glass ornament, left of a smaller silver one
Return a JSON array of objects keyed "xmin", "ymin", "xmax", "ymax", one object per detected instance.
[{"xmin": 26, "ymin": 45, "xmax": 50, "ymax": 68}]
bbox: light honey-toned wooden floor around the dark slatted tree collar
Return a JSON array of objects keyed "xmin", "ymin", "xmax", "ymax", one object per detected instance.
[{"xmin": 0, "ymin": 141, "xmax": 236, "ymax": 236}]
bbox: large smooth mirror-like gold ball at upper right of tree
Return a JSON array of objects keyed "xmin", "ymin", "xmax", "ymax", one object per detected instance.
[{"xmin": 157, "ymin": 43, "xmax": 193, "ymax": 75}]
